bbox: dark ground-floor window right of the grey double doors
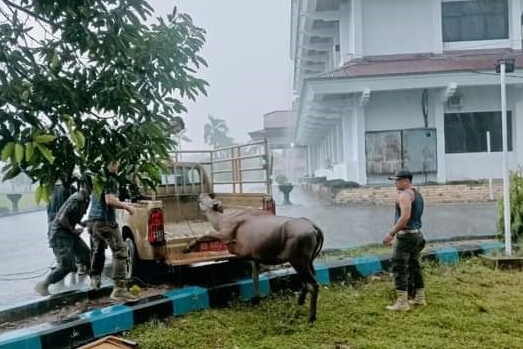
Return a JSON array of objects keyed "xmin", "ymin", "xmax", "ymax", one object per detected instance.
[{"xmin": 445, "ymin": 112, "xmax": 512, "ymax": 154}]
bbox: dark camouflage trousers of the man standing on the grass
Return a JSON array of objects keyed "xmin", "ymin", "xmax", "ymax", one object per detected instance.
[{"xmin": 392, "ymin": 233, "xmax": 425, "ymax": 291}]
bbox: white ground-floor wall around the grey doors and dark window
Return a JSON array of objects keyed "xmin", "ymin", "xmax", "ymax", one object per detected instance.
[{"xmin": 365, "ymin": 86, "xmax": 523, "ymax": 184}]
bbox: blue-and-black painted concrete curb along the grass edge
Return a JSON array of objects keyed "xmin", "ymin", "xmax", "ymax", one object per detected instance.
[{"xmin": 0, "ymin": 242, "xmax": 503, "ymax": 349}]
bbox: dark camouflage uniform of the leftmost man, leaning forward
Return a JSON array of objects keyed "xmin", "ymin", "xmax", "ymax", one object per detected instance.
[{"xmin": 46, "ymin": 192, "xmax": 90, "ymax": 284}]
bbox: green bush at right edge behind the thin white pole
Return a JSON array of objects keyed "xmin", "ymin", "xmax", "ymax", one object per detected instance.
[{"xmin": 497, "ymin": 170, "xmax": 523, "ymax": 242}]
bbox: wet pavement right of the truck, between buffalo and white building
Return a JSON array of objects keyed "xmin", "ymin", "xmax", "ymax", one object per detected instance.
[{"xmin": 274, "ymin": 188, "xmax": 497, "ymax": 248}]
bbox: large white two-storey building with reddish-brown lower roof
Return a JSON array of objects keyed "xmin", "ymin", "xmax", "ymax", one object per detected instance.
[{"xmin": 291, "ymin": 0, "xmax": 523, "ymax": 184}]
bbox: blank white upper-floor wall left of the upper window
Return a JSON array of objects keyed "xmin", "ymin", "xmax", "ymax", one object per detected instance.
[{"xmin": 363, "ymin": 0, "xmax": 441, "ymax": 56}]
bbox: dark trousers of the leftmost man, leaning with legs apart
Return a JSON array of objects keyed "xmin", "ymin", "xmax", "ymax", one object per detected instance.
[{"xmin": 47, "ymin": 232, "xmax": 90, "ymax": 284}]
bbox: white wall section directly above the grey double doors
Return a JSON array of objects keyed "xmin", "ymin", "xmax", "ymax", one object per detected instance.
[{"xmin": 365, "ymin": 90, "xmax": 434, "ymax": 132}]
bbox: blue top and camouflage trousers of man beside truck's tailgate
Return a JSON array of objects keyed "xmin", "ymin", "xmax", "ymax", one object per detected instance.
[{"xmin": 89, "ymin": 177, "xmax": 128, "ymax": 287}]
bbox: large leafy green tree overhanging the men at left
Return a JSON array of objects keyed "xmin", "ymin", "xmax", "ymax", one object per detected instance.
[{"xmin": 0, "ymin": 0, "xmax": 207, "ymax": 200}]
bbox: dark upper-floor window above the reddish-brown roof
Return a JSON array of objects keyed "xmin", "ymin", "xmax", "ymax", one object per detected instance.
[{"xmin": 441, "ymin": 0, "xmax": 508, "ymax": 42}]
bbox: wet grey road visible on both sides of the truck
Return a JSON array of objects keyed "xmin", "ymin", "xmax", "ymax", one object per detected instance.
[{"xmin": 0, "ymin": 190, "xmax": 496, "ymax": 307}]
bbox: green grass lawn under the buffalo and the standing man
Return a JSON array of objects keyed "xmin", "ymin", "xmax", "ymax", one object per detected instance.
[{"xmin": 126, "ymin": 258, "xmax": 523, "ymax": 349}]
